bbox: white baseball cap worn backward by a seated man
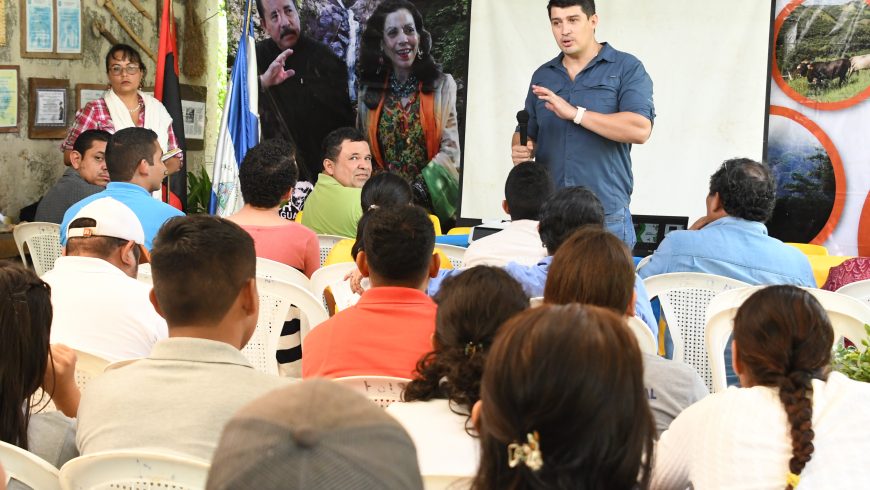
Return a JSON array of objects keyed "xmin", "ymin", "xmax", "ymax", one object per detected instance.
[{"xmin": 66, "ymin": 197, "xmax": 150, "ymax": 263}]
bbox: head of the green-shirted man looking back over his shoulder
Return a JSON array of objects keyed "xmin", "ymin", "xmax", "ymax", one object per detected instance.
[{"xmin": 323, "ymin": 128, "xmax": 372, "ymax": 188}]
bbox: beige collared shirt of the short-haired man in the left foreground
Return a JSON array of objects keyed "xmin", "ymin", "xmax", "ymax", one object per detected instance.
[{"xmin": 76, "ymin": 337, "xmax": 291, "ymax": 461}]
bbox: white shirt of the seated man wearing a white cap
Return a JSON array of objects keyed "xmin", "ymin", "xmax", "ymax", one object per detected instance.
[{"xmin": 43, "ymin": 256, "xmax": 169, "ymax": 362}]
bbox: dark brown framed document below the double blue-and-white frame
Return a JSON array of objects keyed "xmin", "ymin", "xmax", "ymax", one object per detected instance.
[{"xmin": 27, "ymin": 78, "xmax": 69, "ymax": 139}]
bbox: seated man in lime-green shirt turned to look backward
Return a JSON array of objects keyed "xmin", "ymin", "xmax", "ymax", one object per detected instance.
[{"xmin": 302, "ymin": 128, "xmax": 372, "ymax": 237}]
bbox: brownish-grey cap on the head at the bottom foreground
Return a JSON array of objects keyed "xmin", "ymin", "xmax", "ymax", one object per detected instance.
[{"xmin": 206, "ymin": 379, "xmax": 423, "ymax": 490}]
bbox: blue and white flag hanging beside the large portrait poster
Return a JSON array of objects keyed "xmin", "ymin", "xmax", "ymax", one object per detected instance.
[{"xmin": 209, "ymin": 0, "xmax": 260, "ymax": 216}]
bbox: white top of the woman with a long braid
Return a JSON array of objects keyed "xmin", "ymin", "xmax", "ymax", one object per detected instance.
[{"xmin": 651, "ymin": 372, "xmax": 870, "ymax": 490}]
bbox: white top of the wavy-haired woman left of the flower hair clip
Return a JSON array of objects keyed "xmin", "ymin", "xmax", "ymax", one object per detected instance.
[{"xmin": 387, "ymin": 400, "xmax": 480, "ymax": 477}]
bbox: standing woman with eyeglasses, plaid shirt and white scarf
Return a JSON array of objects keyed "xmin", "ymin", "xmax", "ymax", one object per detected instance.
[{"xmin": 60, "ymin": 44, "xmax": 182, "ymax": 174}]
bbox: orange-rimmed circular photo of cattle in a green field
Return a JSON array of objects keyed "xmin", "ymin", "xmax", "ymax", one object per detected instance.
[{"xmin": 773, "ymin": 0, "xmax": 870, "ymax": 110}]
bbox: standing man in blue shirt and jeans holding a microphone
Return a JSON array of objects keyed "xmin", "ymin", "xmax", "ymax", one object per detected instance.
[{"xmin": 511, "ymin": 0, "xmax": 655, "ymax": 247}]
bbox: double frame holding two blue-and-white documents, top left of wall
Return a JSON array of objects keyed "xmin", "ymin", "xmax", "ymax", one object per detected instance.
[{"xmin": 20, "ymin": 0, "xmax": 82, "ymax": 59}]
